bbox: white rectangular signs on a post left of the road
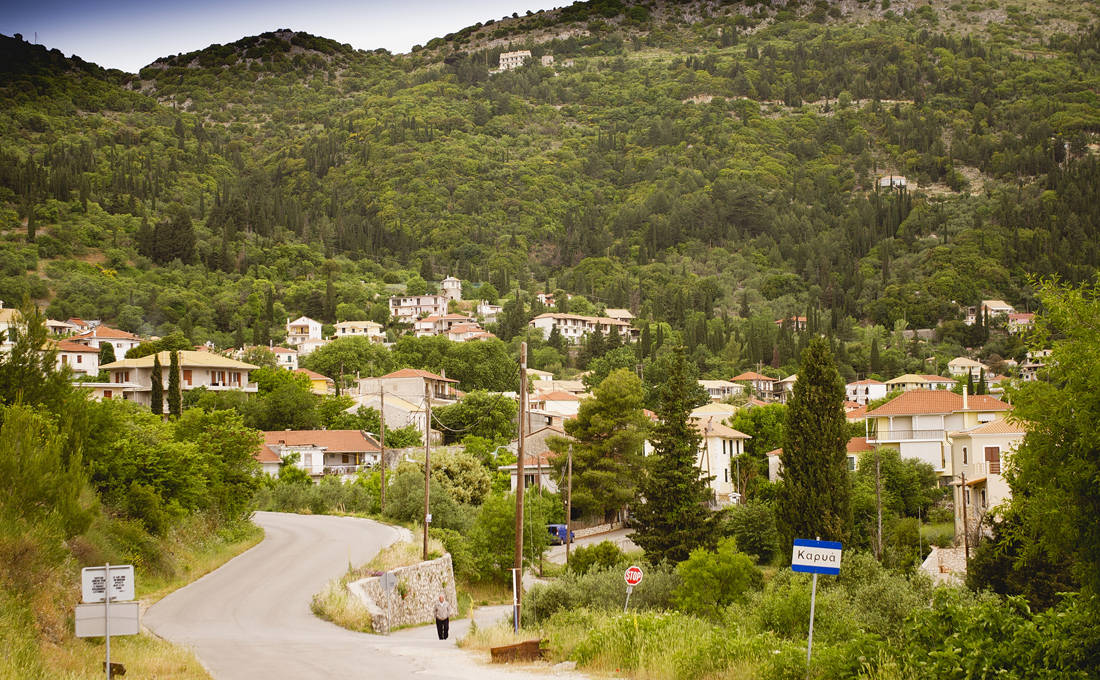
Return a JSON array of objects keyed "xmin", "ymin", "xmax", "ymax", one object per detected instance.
[{"xmin": 76, "ymin": 563, "xmax": 141, "ymax": 680}]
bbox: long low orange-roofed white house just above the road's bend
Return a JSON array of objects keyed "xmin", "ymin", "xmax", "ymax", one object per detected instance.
[{"xmin": 254, "ymin": 430, "xmax": 382, "ymax": 481}]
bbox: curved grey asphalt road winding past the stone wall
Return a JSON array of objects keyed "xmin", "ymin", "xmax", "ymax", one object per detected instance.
[{"xmin": 143, "ymin": 513, "xmax": 580, "ymax": 680}]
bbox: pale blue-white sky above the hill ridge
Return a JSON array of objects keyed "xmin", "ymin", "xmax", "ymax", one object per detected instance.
[{"xmin": 0, "ymin": 0, "xmax": 572, "ymax": 73}]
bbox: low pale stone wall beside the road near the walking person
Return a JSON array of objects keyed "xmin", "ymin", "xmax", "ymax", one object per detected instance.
[{"xmin": 348, "ymin": 553, "xmax": 458, "ymax": 635}]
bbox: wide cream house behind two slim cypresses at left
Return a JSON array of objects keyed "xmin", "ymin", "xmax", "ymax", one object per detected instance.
[{"xmin": 99, "ymin": 350, "xmax": 257, "ymax": 406}]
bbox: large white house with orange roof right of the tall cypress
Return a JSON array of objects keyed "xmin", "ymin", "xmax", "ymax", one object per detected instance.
[{"xmin": 866, "ymin": 388, "xmax": 1011, "ymax": 479}]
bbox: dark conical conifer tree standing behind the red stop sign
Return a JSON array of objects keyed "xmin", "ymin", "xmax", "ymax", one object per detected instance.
[{"xmin": 633, "ymin": 348, "xmax": 717, "ymax": 563}]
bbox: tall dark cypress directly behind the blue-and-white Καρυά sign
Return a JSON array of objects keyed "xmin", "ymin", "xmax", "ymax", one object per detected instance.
[{"xmin": 777, "ymin": 338, "xmax": 851, "ymax": 542}]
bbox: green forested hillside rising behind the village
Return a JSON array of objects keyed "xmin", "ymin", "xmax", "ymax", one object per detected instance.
[{"xmin": 0, "ymin": 0, "xmax": 1100, "ymax": 377}]
